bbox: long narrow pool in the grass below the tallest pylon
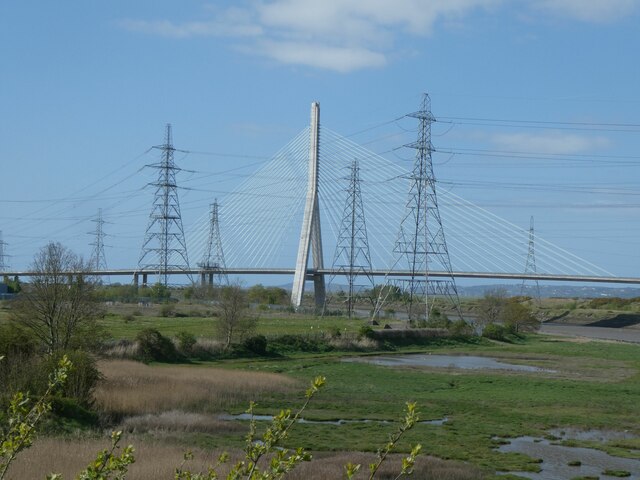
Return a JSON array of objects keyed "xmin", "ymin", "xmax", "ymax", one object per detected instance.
[{"xmin": 343, "ymin": 354, "xmax": 553, "ymax": 372}]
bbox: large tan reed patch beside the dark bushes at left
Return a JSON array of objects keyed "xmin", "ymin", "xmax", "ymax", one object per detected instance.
[{"xmin": 95, "ymin": 360, "xmax": 301, "ymax": 417}]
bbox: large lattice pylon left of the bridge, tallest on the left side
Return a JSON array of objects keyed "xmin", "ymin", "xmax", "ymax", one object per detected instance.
[{"xmin": 138, "ymin": 124, "xmax": 189, "ymax": 285}]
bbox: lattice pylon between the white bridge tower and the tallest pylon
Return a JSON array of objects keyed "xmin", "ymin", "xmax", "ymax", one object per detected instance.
[{"xmin": 333, "ymin": 160, "xmax": 373, "ymax": 318}]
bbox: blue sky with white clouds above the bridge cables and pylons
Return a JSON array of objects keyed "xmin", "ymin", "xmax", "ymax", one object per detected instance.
[{"xmin": 0, "ymin": 0, "xmax": 640, "ymax": 284}]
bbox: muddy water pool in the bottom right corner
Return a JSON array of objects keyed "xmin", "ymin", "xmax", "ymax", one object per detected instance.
[{"xmin": 498, "ymin": 437, "xmax": 640, "ymax": 480}]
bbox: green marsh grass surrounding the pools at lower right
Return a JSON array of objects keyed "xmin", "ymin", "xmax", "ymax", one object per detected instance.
[{"xmin": 196, "ymin": 336, "xmax": 640, "ymax": 471}]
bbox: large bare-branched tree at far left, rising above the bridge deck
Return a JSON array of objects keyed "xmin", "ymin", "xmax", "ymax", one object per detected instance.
[{"xmin": 12, "ymin": 242, "xmax": 102, "ymax": 353}]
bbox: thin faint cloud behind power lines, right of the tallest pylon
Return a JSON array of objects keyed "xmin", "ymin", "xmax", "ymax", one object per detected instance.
[{"xmin": 491, "ymin": 131, "xmax": 610, "ymax": 155}]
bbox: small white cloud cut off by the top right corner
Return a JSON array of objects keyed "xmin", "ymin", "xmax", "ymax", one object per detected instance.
[{"xmin": 534, "ymin": 0, "xmax": 638, "ymax": 23}]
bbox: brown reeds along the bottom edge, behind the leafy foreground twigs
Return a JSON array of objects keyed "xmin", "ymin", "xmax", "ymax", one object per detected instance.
[{"xmin": 8, "ymin": 437, "xmax": 483, "ymax": 480}]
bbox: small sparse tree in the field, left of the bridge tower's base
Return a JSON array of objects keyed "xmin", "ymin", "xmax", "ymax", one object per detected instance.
[{"xmin": 218, "ymin": 285, "xmax": 256, "ymax": 348}]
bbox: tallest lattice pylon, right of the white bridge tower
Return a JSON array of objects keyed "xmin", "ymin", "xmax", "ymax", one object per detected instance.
[{"xmin": 394, "ymin": 93, "xmax": 461, "ymax": 320}]
